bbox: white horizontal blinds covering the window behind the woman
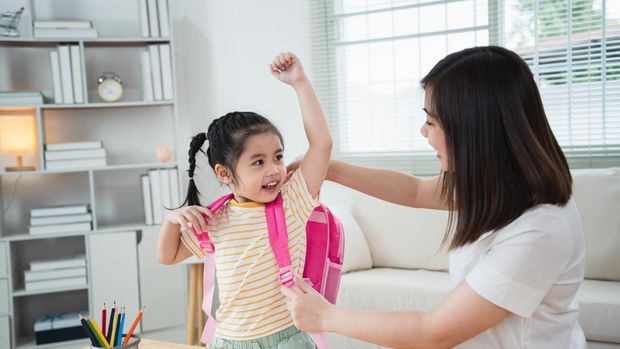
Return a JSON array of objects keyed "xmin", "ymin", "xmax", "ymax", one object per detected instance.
[{"xmin": 310, "ymin": 0, "xmax": 620, "ymax": 174}]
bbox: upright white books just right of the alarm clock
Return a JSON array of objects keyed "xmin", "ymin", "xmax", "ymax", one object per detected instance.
[{"xmin": 141, "ymin": 44, "xmax": 174, "ymax": 101}]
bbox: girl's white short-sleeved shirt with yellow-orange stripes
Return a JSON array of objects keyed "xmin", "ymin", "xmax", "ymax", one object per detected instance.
[{"xmin": 181, "ymin": 171, "xmax": 319, "ymax": 340}]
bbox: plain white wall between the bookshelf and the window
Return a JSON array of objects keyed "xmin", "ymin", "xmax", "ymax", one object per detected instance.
[{"xmin": 170, "ymin": 0, "xmax": 352, "ymax": 204}]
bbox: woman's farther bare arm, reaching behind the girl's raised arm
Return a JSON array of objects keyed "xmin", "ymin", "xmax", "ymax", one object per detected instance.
[{"xmin": 327, "ymin": 160, "xmax": 448, "ymax": 210}]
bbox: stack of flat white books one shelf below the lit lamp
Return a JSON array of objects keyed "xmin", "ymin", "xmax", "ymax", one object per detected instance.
[{"xmin": 30, "ymin": 204, "xmax": 93, "ymax": 235}]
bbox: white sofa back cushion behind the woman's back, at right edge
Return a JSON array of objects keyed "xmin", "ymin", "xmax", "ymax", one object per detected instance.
[{"xmin": 572, "ymin": 168, "xmax": 620, "ymax": 281}]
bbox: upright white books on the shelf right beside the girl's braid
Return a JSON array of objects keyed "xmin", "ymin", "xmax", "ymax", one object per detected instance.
[{"xmin": 140, "ymin": 168, "xmax": 181, "ymax": 224}]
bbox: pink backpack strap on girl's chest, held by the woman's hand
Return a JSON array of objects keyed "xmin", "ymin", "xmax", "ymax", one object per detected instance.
[{"xmin": 265, "ymin": 194, "xmax": 294, "ymax": 287}]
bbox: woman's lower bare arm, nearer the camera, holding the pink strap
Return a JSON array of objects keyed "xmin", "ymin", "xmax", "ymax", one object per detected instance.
[{"xmin": 282, "ymin": 278, "xmax": 511, "ymax": 349}]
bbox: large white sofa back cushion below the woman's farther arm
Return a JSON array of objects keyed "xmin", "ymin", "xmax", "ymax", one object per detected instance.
[{"xmin": 352, "ymin": 192, "xmax": 448, "ymax": 270}]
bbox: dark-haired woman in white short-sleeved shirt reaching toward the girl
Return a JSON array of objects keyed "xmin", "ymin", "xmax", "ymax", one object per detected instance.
[{"xmin": 282, "ymin": 47, "xmax": 586, "ymax": 348}]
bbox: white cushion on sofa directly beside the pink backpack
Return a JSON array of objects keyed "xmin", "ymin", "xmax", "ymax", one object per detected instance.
[{"xmin": 329, "ymin": 206, "xmax": 372, "ymax": 273}]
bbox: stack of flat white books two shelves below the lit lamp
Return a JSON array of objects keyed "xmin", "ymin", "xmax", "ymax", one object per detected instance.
[{"xmin": 24, "ymin": 255, "xmax": 87, "ymax": 291}]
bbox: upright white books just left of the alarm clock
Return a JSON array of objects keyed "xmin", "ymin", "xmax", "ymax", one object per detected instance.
[{"xmin": 50, "ymin": 45, "xmax": 85, "ymax": 104}]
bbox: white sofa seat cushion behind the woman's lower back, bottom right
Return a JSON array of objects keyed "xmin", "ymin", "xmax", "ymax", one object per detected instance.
[{"xmin": 577, "ymin": 280, "xmax": 620, "ymax": 343}]
